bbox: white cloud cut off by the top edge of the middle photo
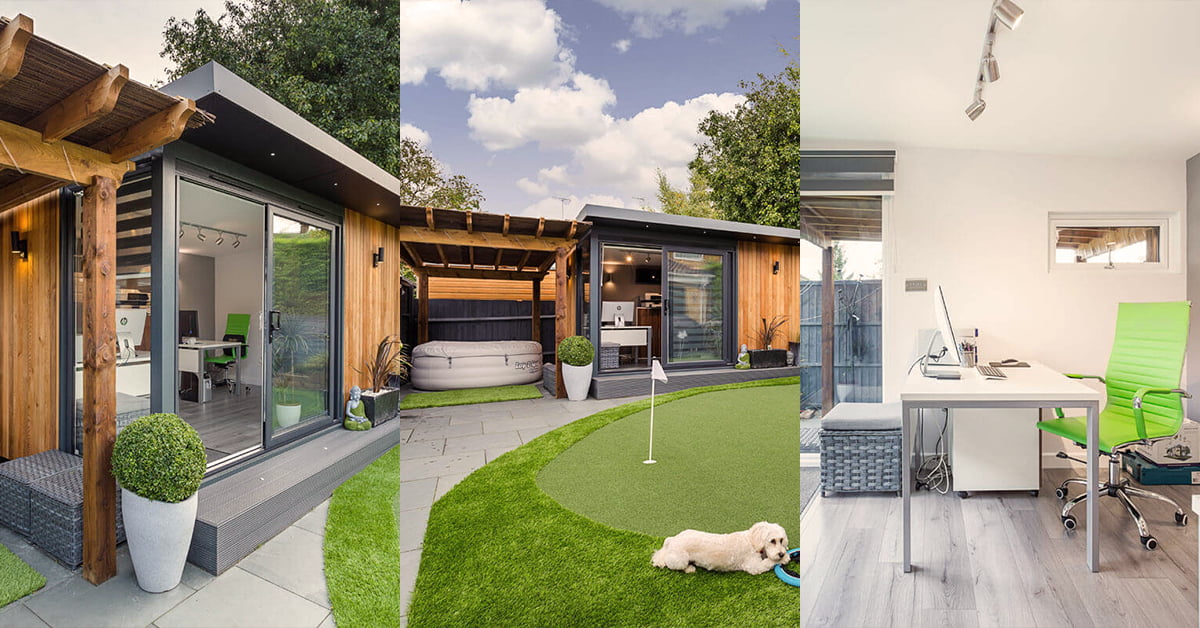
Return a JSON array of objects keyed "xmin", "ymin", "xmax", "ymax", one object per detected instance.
[{"xmin": 598, "ymin": 0, "xmax": 767, "ymax": 37}]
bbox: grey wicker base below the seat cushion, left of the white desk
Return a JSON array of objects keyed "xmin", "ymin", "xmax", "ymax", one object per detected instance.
[{"xmin": 821, "ymin": 430, "xmax": 900, "ymax": 497}]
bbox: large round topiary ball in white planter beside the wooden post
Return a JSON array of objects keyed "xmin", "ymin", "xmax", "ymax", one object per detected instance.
[{"xmin": 112, "ymin": 414, "xmax": 205, "ymax": 593}]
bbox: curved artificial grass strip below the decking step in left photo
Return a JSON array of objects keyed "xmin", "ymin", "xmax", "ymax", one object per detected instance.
[{"xmin": 325, "ymin": 445, "xmax": 400, "ymax": 628}]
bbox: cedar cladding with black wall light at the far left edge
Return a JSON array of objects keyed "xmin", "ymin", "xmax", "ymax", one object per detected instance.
[{"xmin": 0, "ymin": 192, "xmax": 59, "ymax": 459}]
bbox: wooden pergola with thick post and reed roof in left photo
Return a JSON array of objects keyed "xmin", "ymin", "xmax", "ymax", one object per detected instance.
[{"xmin": 0, "ymin": 16, "xmax": 211, "ymax": 584}]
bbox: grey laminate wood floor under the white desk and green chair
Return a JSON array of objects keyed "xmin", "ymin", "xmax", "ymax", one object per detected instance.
[{"xmin": 799, "ymin": 469, "xmax": 1200, "ymax": 628}]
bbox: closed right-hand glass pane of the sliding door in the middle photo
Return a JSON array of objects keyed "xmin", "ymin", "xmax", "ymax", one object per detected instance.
[{"xmin": 664, "ymin": 250, "xmax": 730, "ymax": 364}]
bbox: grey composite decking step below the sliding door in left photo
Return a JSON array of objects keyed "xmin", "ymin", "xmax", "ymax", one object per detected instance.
[{"xmin": 187, "ymin": 420, "xmax": 400, "ymax": 574}]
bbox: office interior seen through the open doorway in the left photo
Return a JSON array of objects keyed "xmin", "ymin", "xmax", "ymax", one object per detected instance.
[{"xmin": 178, "ymin": 179, "xmax": 265, "ymax": 465}]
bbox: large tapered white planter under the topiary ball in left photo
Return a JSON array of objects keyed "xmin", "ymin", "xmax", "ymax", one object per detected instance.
[{"xmin": 121, "ymin": 489, "xmax": 197, "ymax": 593}]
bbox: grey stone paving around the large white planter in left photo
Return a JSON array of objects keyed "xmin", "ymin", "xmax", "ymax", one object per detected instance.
[{"xmin": 0, "ymin": 500, "xmax": 334, "ymax": 628}]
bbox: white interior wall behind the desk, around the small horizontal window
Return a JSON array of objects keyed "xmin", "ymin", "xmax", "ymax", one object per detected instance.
[{"xmin": 883, "ymin": 149, "xmax": 1187, "ymax": 451}]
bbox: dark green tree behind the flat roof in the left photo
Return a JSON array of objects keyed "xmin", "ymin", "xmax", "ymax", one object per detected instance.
[{"xmin": 162, "ymin": 0, "xmax": 403, "ymax": 178}]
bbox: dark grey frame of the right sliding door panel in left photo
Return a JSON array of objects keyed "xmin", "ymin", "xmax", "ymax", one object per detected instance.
[{"xmin": 262, "ymin": 202, "xmax": 342, "ymax": 450}]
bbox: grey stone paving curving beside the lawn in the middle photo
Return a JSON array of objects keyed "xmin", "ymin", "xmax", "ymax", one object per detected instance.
[{"xmin": 397, "ymin": 391, "xmax": 641, "ymax": 627}]
